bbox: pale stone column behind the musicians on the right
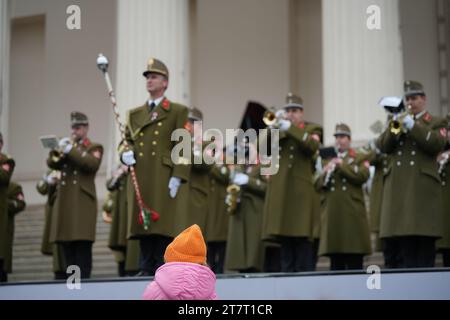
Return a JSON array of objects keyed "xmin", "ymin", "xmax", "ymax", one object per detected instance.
[{"xmin": 322, "ymin": 0, "xmax": 403, "ymax": 144}]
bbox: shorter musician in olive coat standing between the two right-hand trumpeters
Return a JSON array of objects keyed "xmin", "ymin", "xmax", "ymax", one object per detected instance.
[{"xmin": 315, "ymin": 123, "xmax": 371, "ymax": 270}]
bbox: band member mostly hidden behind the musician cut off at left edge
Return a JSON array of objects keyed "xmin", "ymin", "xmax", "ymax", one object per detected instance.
[{"xmin": 4, "ymin": 181, "xmax": 26, "ymax": 282}]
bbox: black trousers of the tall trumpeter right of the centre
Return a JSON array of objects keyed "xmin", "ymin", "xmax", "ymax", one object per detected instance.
[{"xmin": 279, "ymin": 237, "xmax": 314, "ymax": 272}]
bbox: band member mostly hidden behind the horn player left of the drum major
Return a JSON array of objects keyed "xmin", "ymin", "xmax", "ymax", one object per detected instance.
[{"xmin": 36, "ymin": 170, "xmax": 67, "ymax": 280}]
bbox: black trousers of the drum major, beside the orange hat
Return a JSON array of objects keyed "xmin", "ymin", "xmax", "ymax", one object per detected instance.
[{"xmin": 139, "ymin": 234, "xmax": 173, "ymax": 276}]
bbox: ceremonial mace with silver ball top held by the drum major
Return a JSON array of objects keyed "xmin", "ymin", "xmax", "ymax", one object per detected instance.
[{"xmin": 97, "ymin": 53, "xmax": 159, "ymax": 230}]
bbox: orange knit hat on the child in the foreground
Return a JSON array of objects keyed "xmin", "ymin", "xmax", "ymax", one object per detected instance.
[{"xmin": 164, "ymin": 224, "xmax": 206, "ymax": 264}]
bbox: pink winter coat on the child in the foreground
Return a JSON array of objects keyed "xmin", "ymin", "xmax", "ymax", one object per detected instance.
[{"xmin": 142, "ymin": 262, "xmax": 217, "ymax": 300}]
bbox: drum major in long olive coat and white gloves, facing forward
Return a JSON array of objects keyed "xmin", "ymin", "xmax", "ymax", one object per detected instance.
[{"xmin": 121, "ymin": 58, "xmax": 190, "ymax": 276}]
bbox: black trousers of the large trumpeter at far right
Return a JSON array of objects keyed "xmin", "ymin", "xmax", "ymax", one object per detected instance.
[{"xmin": 398, "ymin": 236, "xmax": 437, "ymax": 268}]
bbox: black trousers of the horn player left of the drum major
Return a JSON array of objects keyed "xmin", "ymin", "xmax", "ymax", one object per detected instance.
[{"xmin": 61, "ymin": 241, "xmax": 92, "ymax": 279}]
